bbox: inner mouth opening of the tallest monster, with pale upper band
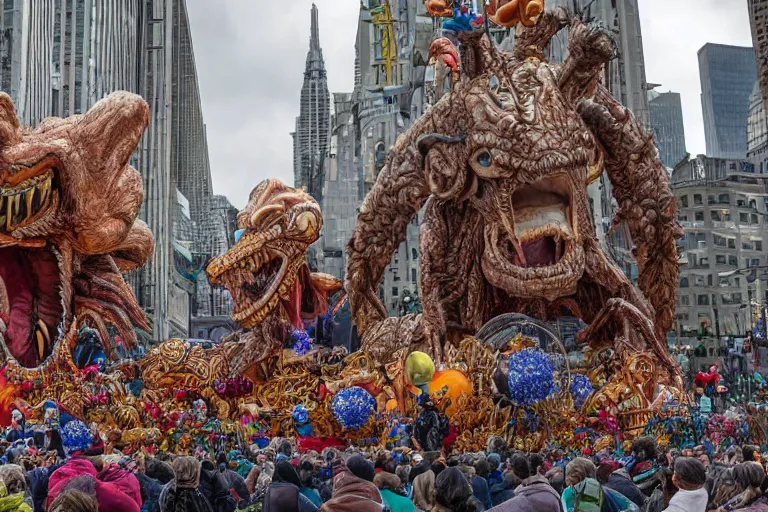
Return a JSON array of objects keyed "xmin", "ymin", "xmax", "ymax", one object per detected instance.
[{"xmin": 506, "ymin": 177, "xmax": 573, "ymax": 268}]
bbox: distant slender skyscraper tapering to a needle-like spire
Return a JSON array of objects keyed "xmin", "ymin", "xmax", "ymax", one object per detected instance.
[{"xmin": 293, "ymin": 4, "xmax": 330, "ymax": 204}]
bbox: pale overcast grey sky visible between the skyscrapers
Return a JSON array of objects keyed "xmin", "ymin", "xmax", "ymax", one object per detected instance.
[{"xmin": 187, "ymin": 0, "xmax": 751, "ymax": 208}]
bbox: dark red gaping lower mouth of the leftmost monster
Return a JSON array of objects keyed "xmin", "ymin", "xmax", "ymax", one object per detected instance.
[{"xmin": 0, "ymin": 246, "xmax": 66, "ymax": 368}]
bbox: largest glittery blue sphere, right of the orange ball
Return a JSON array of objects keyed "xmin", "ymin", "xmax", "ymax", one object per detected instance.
[{"xmin": 509, "ymin": 348, "xmax": 555, "ymax": 407}]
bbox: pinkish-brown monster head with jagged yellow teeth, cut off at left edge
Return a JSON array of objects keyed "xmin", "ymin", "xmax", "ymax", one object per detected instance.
[{"xmin": 0, "ymin": 92, "xmax": 154, "ymax": 368}]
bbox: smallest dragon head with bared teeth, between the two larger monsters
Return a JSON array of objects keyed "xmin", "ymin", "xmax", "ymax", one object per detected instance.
[{"xmin": 206, "ymin": 180, "xmax": 341, "ymax": 374}]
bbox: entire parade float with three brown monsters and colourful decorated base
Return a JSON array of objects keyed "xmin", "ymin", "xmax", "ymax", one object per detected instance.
[{"xmin": 0, "ymin": 0, "xmax": 712, "ymax": 453}]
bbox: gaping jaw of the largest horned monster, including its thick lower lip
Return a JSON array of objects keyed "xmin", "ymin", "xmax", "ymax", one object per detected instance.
[{"xmin": 483, "ymin": 174, "xmax": 583, "ymax": 298}]
